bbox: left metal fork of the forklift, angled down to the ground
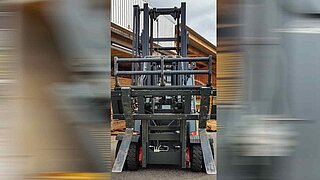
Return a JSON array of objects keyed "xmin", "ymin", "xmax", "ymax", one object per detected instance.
[{"xmin": 112, "ymin": 128, "xmax": 133, "ymax": 172}]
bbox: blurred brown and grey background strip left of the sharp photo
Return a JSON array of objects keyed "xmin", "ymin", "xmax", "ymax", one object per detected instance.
[{"xmin": 0, "ymin": 0, "xmax": 111, "ymax": 179}]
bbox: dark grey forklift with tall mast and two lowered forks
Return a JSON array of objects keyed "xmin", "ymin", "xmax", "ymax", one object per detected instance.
[{"xmin": 111, "ymin": 2, "xmax": 216, "ymax": 174}]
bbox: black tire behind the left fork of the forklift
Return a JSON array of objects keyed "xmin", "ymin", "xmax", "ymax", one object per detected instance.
[{"xmin": 126, "ymin": 143, "xmax": 140, "ymax": 171}]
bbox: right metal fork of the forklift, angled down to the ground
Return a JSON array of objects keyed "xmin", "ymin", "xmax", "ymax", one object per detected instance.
[{"xmin": 199, "ymin": 129, "xmax": 217, "ymax": 174}]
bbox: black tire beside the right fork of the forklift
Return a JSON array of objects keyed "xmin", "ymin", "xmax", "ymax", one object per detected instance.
[{"xmin": 190, "ymin": 144, "xmax": 203, "ymax": 172}]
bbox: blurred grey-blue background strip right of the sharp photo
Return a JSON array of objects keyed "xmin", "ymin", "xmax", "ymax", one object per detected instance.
[{"xmin": 217, "ymin": 0, "xmax": 320, "ymax": 180}]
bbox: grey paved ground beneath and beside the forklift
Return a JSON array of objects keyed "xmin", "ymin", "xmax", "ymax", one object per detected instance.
[{"xmin": 111, "ymin": 132, "xmax": 217, "ymax": 180}]
